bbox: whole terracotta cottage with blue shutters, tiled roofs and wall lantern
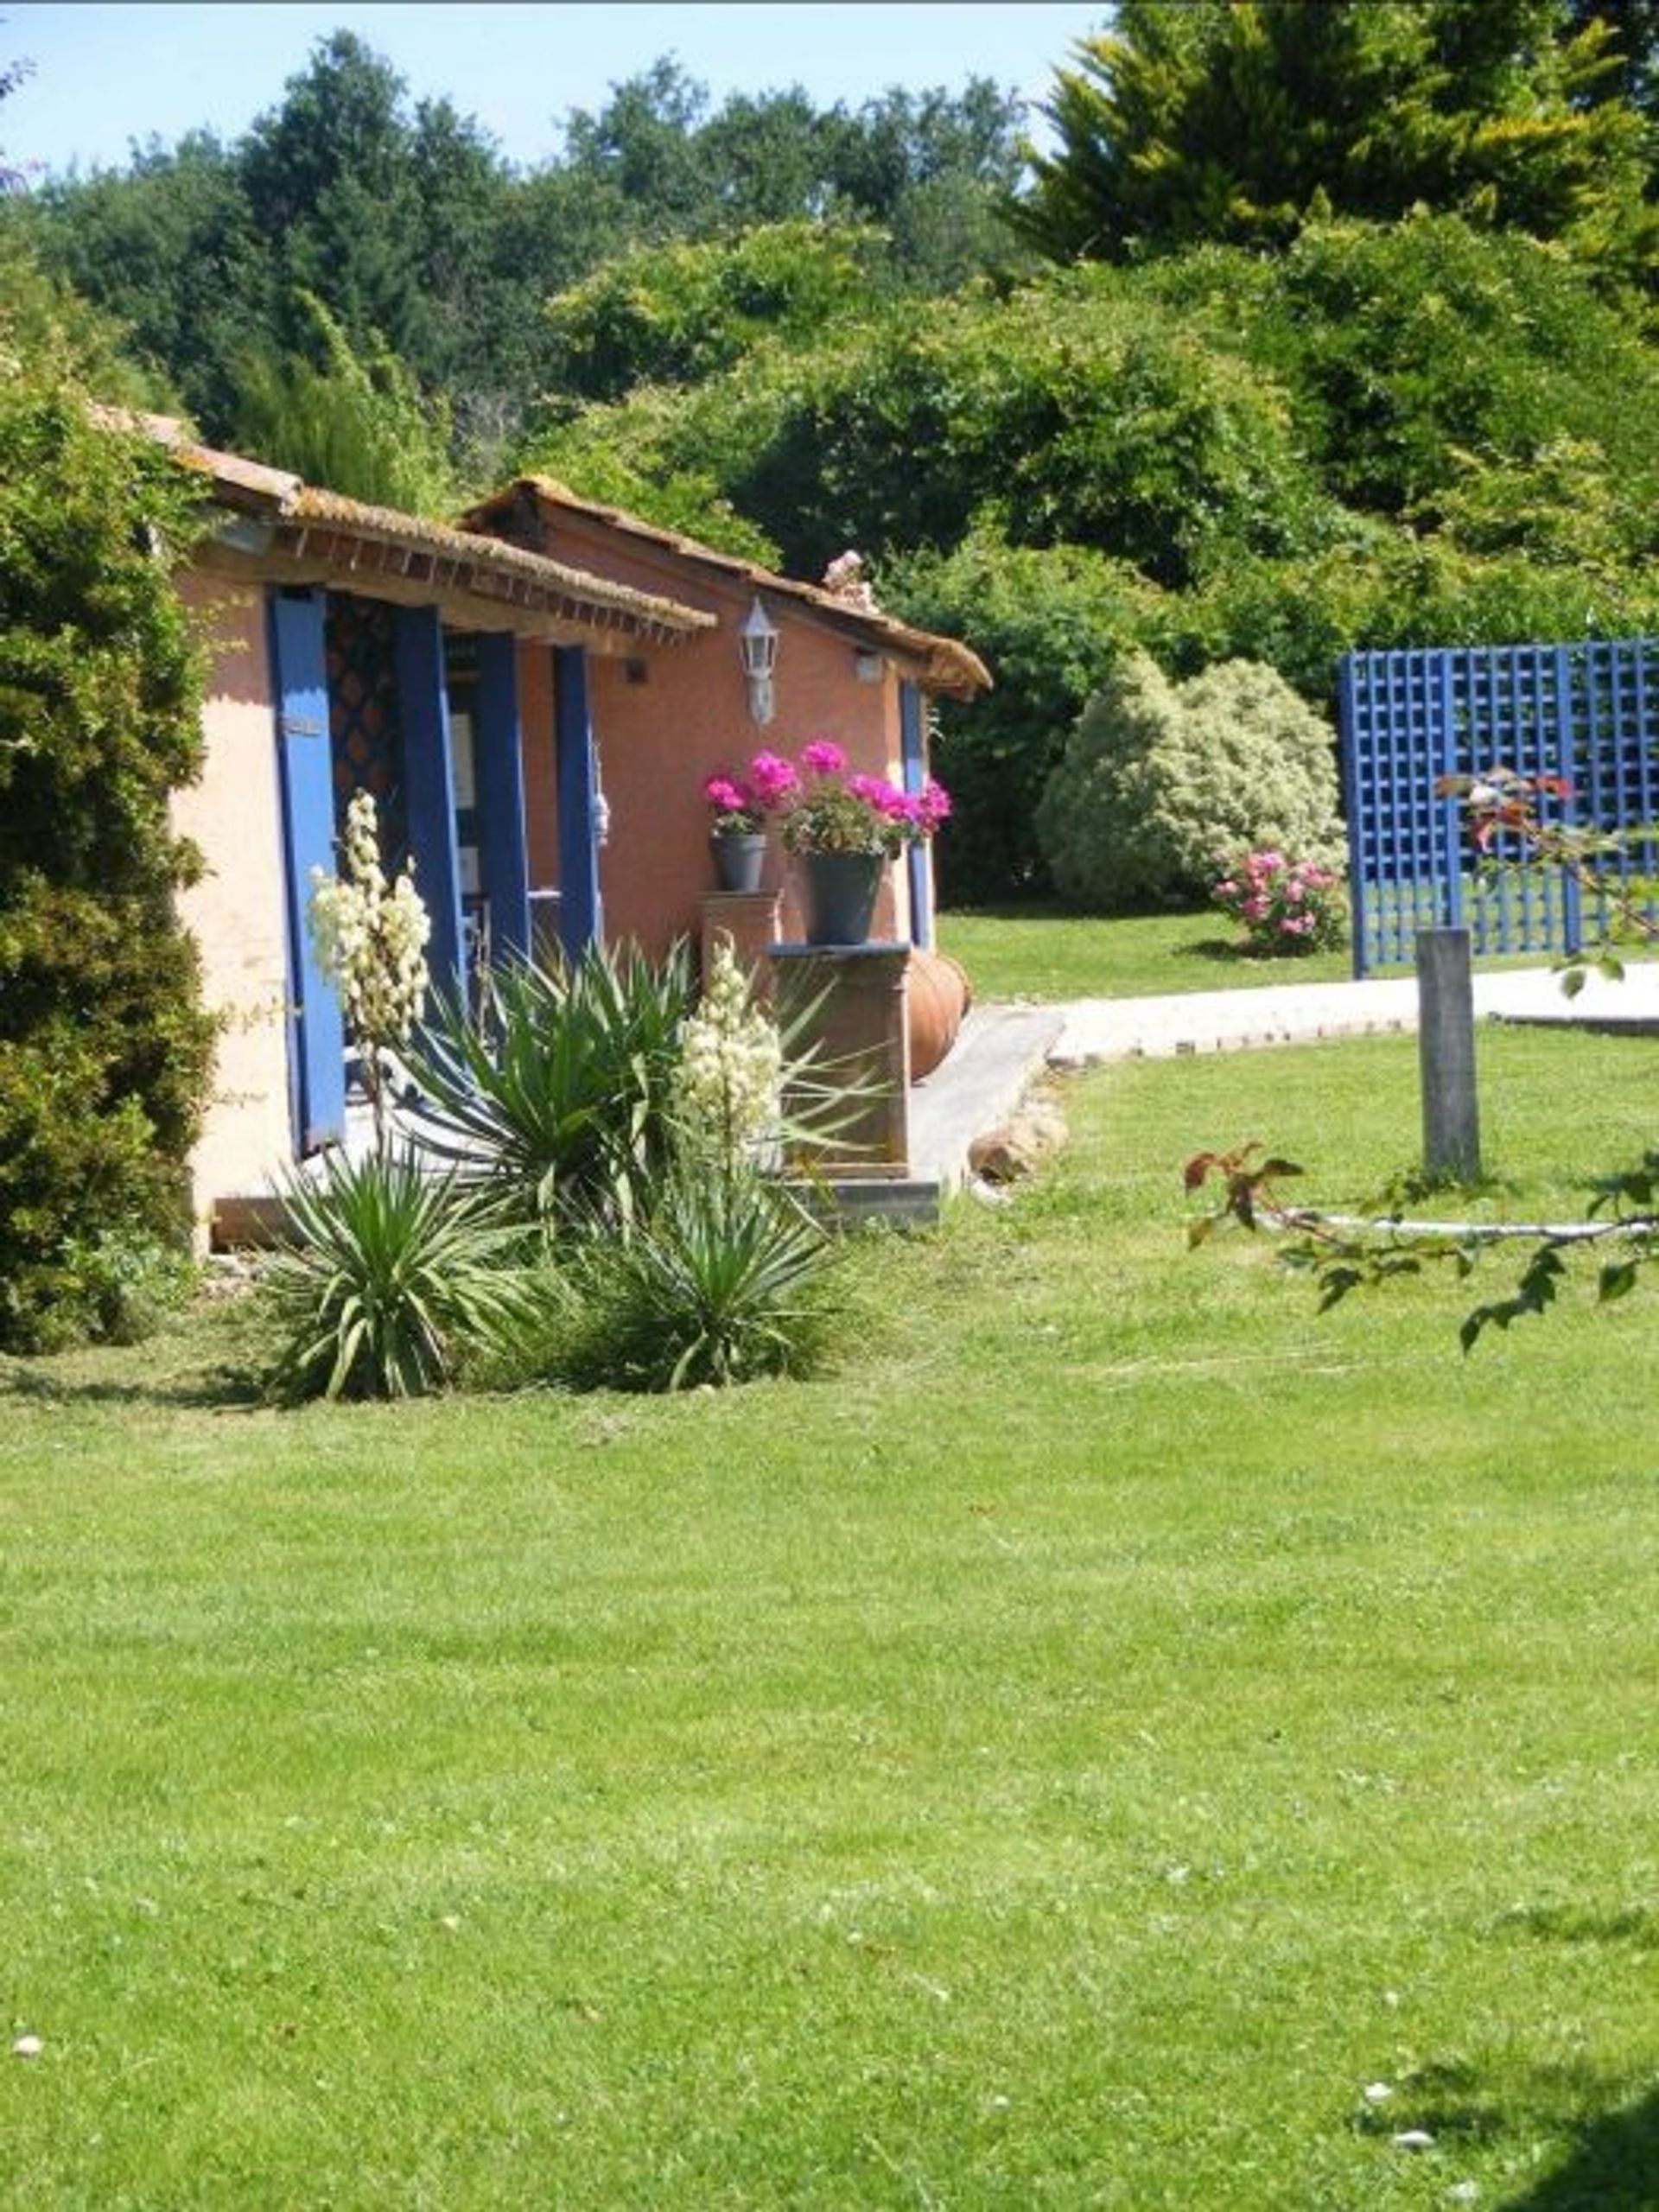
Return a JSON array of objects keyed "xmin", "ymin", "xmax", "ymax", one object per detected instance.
[{"xmin": 128, "ymin": 418, "xmax": 988, "ymax": 1234}]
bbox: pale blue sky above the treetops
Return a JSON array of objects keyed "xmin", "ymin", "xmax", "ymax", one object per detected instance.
[{"xmin": 0, "ymin": 0, "xmax": 1109, "ymax": 173}]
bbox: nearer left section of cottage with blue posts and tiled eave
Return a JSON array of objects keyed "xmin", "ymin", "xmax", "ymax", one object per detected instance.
[{"xmin": 149, "ymin": 423, "xmax": 712, "ymax": 1230}]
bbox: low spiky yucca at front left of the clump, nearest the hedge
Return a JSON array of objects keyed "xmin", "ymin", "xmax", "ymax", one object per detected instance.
[{"xmin": 264, "ymin": 1153, "xmax": 526, "ymax": 1402}]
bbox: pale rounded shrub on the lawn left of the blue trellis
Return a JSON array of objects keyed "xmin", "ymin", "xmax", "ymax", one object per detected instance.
[{"xmin": 1038, "ymin": 652, "xmax": 1343, "ymax": 913}]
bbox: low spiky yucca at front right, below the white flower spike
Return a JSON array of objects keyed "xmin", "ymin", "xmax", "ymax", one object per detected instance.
[{"xmin": 562, "ymin": 1161, "xmax": 834, "ymax": 1391}]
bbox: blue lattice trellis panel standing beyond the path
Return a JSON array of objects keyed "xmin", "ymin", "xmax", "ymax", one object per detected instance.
[{"xmin": 1340, "ymin": 637, "xmax": 1659, "ymax": 976}]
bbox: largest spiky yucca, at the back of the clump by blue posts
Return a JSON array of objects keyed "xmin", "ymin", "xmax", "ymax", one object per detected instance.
[{"xmin": 407, "ymin": 943, "xmax": 692, "ymax": 1225}]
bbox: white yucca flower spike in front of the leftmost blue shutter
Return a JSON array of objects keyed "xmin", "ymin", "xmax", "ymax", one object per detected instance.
[{"xmin": 308, "ymin": 791, "xmax": 431, "ymax": 1048}]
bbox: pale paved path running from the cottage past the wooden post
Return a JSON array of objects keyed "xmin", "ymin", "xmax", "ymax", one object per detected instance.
[{"xmin": 909, "ymin": 960, "xmax": 1659, "ymax": 1188}]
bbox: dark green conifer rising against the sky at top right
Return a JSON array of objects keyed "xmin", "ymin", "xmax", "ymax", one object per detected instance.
[{"xmin": 1018, "ymin": 0, "xmax": 1655, "ymax": 276}]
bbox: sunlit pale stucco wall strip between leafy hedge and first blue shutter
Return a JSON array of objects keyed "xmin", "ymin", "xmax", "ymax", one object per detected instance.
[{"xmin": 173, "ymin": 575, "xmax": 292, "ymax": 1221}]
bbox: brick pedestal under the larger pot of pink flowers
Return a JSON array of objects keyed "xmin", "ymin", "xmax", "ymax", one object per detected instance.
[{"xmin": 767, "ymin": 944, "xmax": 909, "ymax": 1179}]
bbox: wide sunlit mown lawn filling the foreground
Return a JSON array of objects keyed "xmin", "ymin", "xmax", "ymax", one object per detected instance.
[{"xmin": 0, "ymin": 1031, "xmax": 1659, "ymax": 2212}]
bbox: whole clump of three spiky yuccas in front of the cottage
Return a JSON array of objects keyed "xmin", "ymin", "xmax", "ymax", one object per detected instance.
[{"xmin": 265, "ymin": 947, "xmax": 841, "ymax": 1400}]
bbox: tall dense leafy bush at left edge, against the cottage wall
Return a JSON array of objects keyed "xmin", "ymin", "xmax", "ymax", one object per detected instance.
[{"xmin": 0, "ymin": 276, "xmax": 210, "ymax": 1344}]
